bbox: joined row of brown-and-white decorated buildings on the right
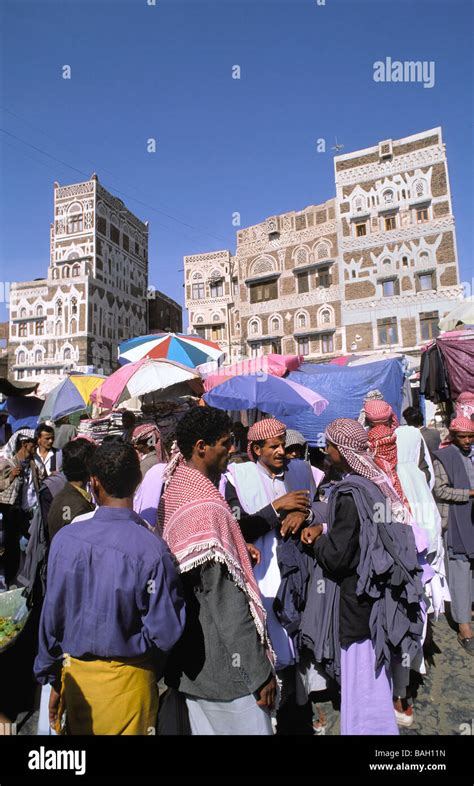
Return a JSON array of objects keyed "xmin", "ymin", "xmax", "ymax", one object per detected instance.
[{"xmin": 184, "ymin": 128, "xmax": 462, "ymax": 360}]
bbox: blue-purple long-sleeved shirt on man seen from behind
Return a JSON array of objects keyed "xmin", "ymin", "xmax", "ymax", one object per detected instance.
[{"xmin": 34, "ymin": 507, "xmax": 185, "ymax": 684}]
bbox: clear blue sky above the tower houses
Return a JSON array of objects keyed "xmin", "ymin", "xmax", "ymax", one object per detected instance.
[{"xmin": 0, "ymin": 0, "xmax": 474, "ymax": 319}]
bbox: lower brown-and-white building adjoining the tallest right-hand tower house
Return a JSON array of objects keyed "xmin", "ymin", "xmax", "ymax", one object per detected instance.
[{"xmin": 184, "ymin": 200, "xmax": 342, "ymax": 360}]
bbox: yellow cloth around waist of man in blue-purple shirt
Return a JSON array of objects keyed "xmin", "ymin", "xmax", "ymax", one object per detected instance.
[{"xmin": 57, "ymin": 655, "xmax": 158, "ymax": 735}]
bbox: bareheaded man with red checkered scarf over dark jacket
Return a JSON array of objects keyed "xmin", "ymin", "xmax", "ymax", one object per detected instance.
[{"xmin": 158, "ymin": 407, "xmax": 275, "ymax": 735}]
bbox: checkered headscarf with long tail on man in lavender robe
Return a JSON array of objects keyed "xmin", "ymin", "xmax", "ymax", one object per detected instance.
[{"xmin": 325, "ymin": 418, "xmax": 411, "ymax": 523}]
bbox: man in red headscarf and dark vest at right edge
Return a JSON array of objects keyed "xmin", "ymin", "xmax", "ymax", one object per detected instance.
[{"xmin": 433, "ymin": 417, "xmax": 474, "ymax": 655}]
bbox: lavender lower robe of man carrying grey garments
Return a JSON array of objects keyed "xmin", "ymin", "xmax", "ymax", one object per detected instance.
[{"xmin": 341, "ymin": 639, "xmax": 399, "ymax": 735}]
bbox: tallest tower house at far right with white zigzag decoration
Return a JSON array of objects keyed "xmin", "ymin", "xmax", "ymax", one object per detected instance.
[{"xmin": 334, "ymin": 128, "xmax": 462, "ymax": 352}]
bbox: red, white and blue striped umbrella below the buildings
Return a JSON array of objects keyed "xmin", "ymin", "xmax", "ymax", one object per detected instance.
[{"xmin": 119, "ymin": 333, "xmax": 224, "ymax": 368}]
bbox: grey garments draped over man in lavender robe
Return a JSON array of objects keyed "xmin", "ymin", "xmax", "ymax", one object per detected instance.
[{"xmin": 301, "ymin": 475, "xmax": 423, "ymax": 680}]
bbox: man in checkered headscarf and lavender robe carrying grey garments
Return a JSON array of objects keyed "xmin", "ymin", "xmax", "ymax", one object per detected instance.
[{"xmin": 300, "ymin": 418, "xmax": 423, "ymax": 734}]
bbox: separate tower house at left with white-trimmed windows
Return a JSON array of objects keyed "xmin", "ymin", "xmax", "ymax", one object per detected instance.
[{"xmin": 9, "ymin": 174, "xmax": 148, "ymax": 379}]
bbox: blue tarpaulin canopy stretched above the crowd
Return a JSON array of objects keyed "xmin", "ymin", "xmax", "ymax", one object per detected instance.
[{"xmin": 285, "ymin": 358, "xmax": 405, "ymax": 447}]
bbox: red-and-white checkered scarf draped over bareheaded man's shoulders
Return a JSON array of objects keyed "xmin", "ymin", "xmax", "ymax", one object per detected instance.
[{"xmin": 158, "ymin": 460, "xmax": 274, "ymax": 663}]
